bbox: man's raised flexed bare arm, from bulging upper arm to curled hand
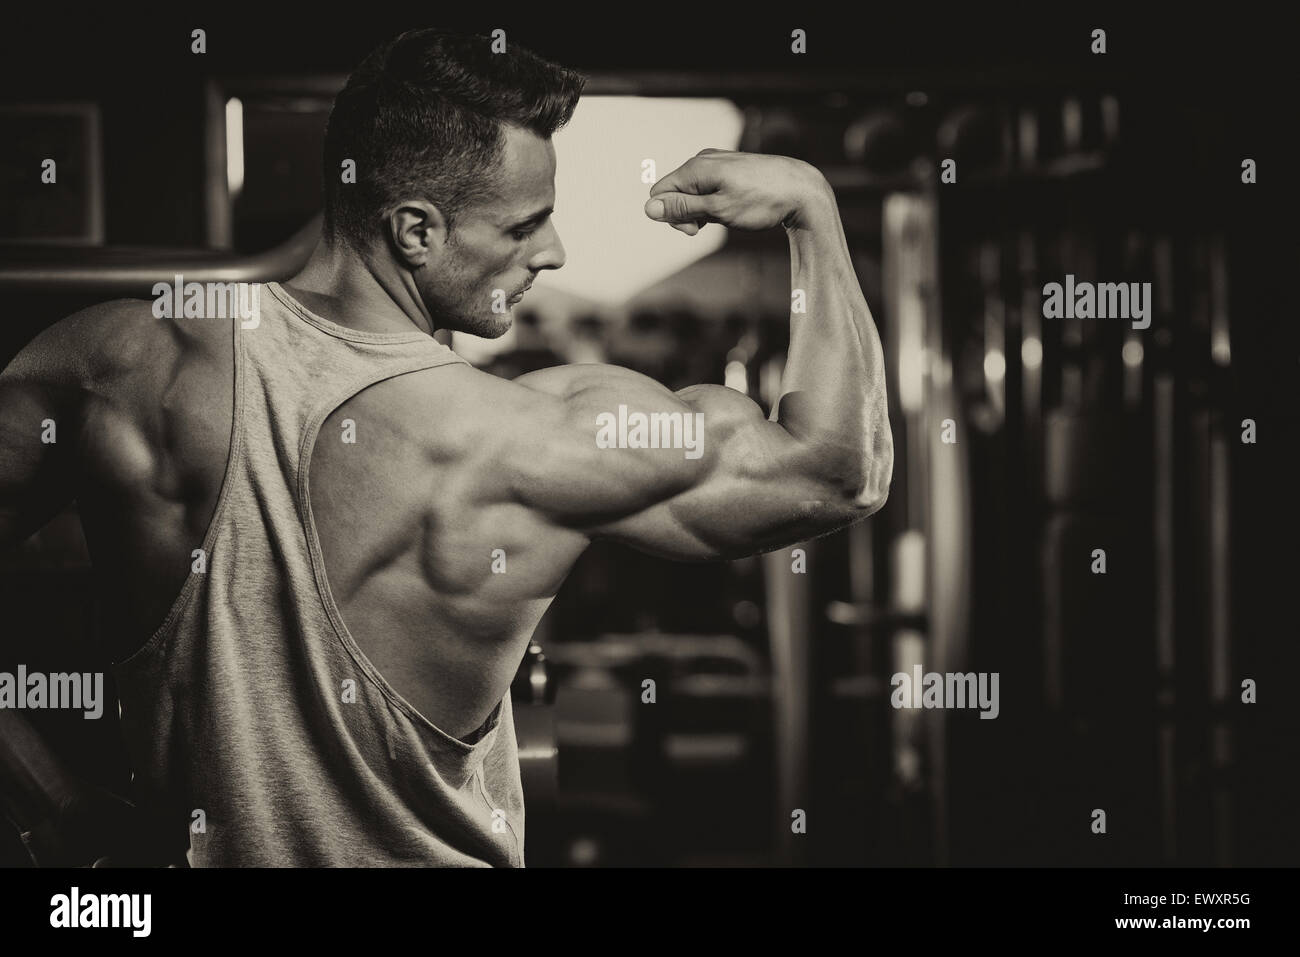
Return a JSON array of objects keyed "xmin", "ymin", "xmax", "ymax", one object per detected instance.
[{"xmin": 488, "ymin": 151, "xmax": 893, "ymax": 559}]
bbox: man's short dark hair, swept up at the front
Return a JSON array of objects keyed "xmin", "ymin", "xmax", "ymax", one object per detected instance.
[{"xmin": 324, "ymin": 29, "xmax": 586, "ymax": 248}]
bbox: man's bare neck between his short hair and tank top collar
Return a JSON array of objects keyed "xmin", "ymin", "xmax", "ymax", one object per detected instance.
[{"xmin": 281, "ymin": 238, "xmax": 437, "ymax": 335}]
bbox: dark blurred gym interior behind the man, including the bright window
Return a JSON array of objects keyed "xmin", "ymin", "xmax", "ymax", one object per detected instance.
[{"xmin": 0, "ymin": 17, "xmax": 1300, "ymax": 867}]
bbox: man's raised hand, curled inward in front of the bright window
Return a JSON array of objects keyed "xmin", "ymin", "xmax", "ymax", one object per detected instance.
[{"xmin": 645, "ymin": 150, "xmax": 835, "ymax": 235}]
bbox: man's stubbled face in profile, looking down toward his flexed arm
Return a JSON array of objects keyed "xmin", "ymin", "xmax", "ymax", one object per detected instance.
[{"xmin": 416, "ymin": 125, "xmax": 564, "ymax": 339}]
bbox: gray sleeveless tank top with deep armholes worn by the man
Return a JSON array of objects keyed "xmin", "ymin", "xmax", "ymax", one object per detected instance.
[{"xmin": 113, "ymin": 282, "xmax": 524, "ymax": 867}]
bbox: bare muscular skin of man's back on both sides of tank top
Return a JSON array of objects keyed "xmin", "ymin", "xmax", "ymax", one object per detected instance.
[{"xmin": 60, "ymin": 287, "xmax": 586, "ymax": 735}]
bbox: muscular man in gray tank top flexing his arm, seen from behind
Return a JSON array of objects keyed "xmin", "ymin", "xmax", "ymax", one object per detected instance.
[{"xmin": 0, "ymin": 31, "xmax": 893, "ymax": 866}]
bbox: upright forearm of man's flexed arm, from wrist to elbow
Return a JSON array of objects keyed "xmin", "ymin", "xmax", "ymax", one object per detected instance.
[{"xmin": 771, "ymin": 181, "xmax": 893, "ymax": 506}]
